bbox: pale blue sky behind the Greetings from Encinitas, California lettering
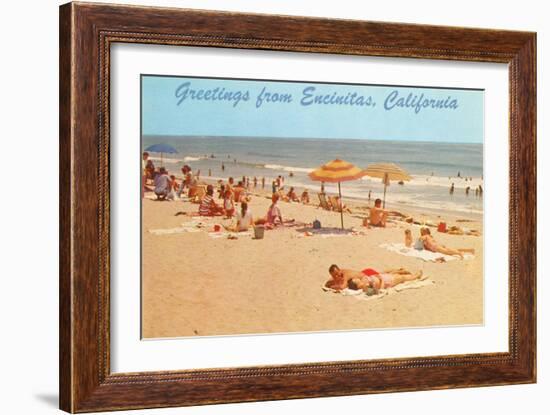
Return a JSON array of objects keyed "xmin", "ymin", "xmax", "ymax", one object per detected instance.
[{"xmin": 142, "ymin": 75, "xmax": 484, "ymax": 143}]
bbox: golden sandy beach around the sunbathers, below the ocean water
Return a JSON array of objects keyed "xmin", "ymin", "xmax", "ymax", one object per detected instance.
[{"xmin": 142, "ymin": 180, "xmax": 483, "ymax": 338}]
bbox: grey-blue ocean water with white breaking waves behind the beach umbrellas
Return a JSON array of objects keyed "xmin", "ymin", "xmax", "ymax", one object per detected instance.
[{"xmin": 142, "ymin": 136, "xmax": 485, "ymax": 213}]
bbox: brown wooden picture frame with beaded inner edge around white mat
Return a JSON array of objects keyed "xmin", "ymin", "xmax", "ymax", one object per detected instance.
[{"xmin": 59, "ymin": 3, "xmax": 536, "ymax": 412}]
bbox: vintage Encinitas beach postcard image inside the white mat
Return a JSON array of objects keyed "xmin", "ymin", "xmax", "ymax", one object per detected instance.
[{"xmin": 140, "ymin": 75, "xmax": 490, "ymax": 339}]
